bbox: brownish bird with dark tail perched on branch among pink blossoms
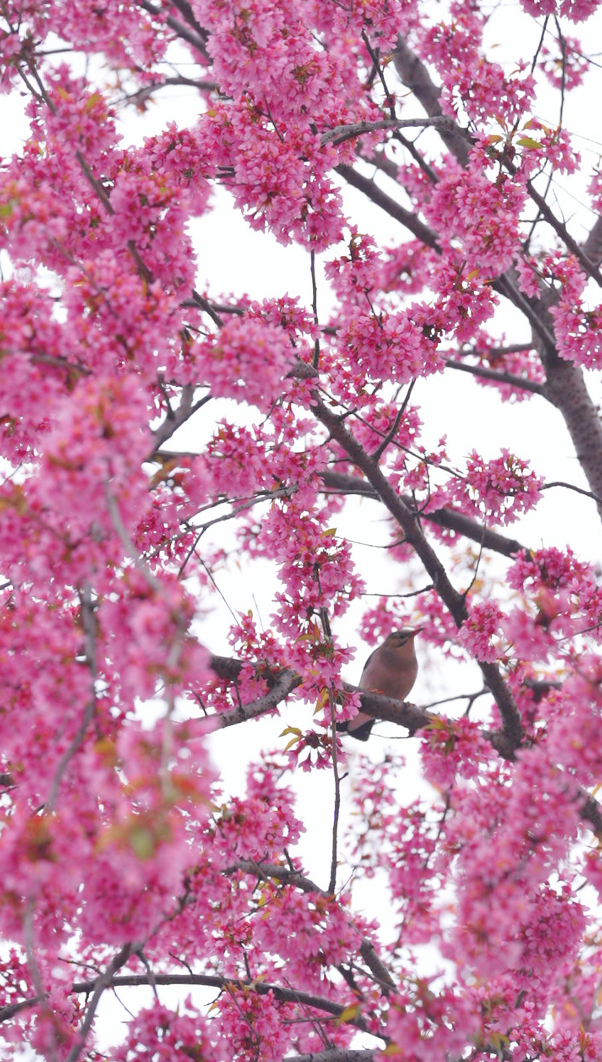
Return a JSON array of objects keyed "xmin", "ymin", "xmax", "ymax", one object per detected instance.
[{"xmin": 337, "ymin": 627, "xmax": 422, "ymax": 741}]
